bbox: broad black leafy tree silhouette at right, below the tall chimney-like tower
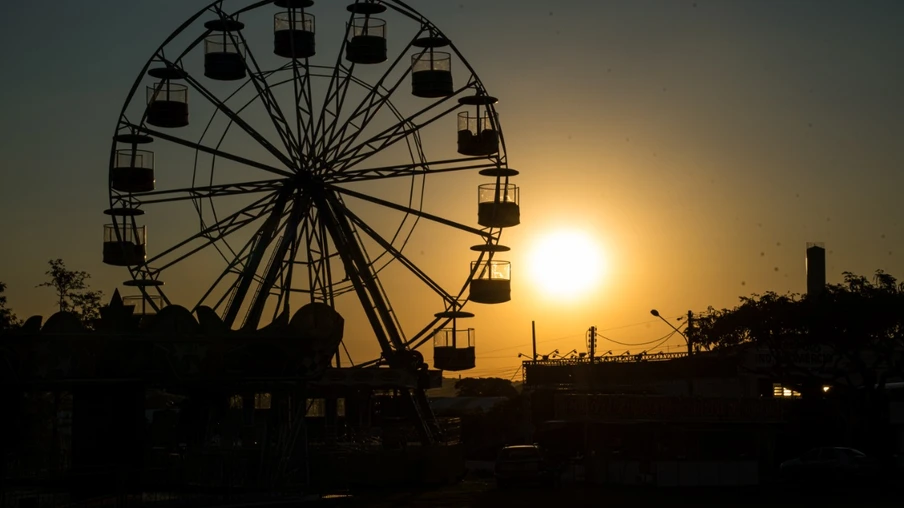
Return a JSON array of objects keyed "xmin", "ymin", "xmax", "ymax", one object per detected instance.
[{"xmin": 692, "ymin": 270, "xmax": 904, "ymax": 390}]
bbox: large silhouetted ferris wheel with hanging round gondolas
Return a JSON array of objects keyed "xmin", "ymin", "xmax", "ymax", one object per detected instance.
[{"xmin": 103, "ymin": 0, "xmax": 520, "ymax": 370}]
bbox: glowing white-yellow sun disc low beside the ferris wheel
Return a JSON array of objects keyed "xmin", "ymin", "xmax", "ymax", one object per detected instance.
[{"xmin": 528, "ymin": 230, "xmax": 606, "ymax": 299}]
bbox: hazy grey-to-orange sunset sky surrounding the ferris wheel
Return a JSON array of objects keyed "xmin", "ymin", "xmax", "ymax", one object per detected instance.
[{"xmin": 0, "ymin": 0, "xmax": 904, "ymax": 377}]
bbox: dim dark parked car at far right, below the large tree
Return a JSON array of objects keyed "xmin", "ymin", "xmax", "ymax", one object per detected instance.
[{"xmin": 779, "ymin": 446, "xmax": 879, "ymax": 483}]
